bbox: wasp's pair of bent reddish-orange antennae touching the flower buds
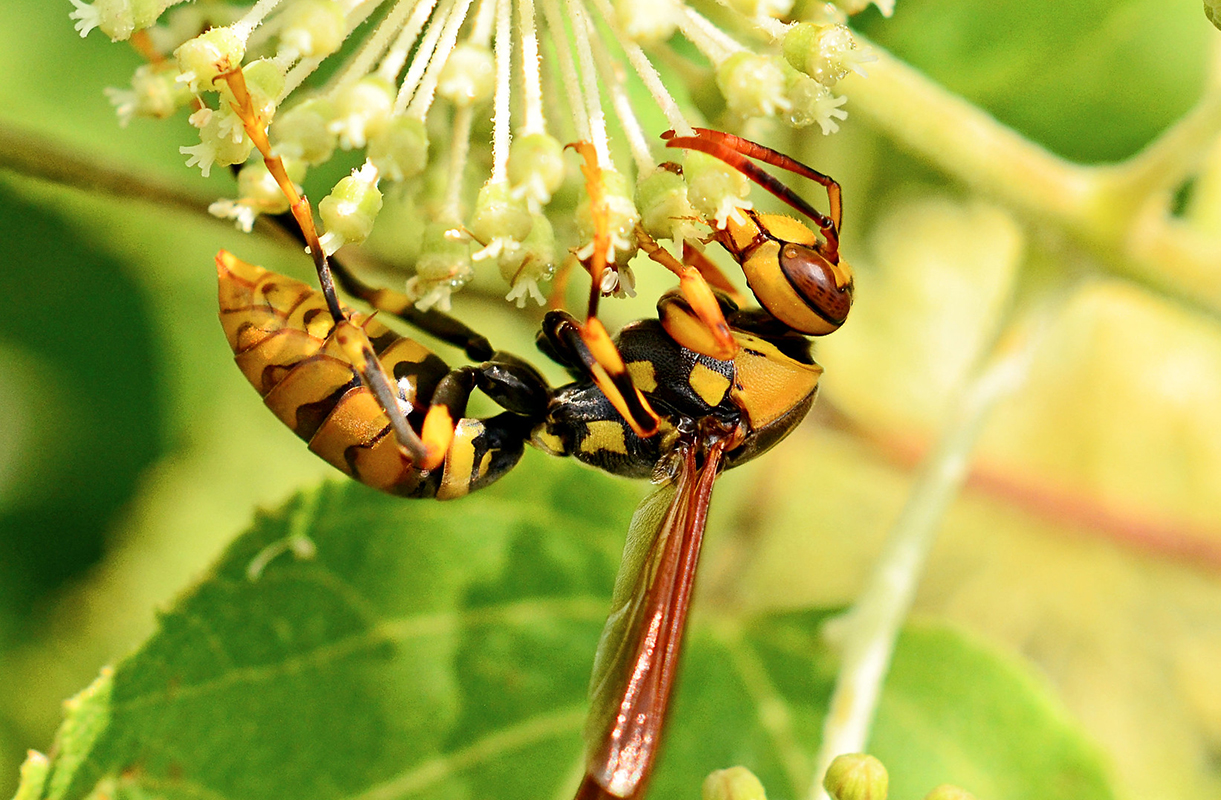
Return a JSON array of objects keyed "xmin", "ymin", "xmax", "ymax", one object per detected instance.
[{"xmin": 662, "ymin": 128, "xmax": 842, "ymax": 261}]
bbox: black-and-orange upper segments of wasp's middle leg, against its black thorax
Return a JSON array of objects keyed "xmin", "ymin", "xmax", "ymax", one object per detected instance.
[{"xmin": 537, "ymin": 310, "xmax": 661, "ymax": 438}]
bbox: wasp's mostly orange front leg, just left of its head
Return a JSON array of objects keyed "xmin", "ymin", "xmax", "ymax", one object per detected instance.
[{"xmin": 636, "ymin": 225, "xmax": 737, "ymax": 362}]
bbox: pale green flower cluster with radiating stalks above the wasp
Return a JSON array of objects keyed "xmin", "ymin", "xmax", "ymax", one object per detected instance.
[{"xmin": 71, "ymin": 0, "xmax": 889, "ymax": 309}]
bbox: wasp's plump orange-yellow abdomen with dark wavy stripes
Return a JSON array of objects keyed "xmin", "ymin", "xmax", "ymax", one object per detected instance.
[{"xmin": 216, "ymin": 252, "xmax": 468, "ymax": 497}]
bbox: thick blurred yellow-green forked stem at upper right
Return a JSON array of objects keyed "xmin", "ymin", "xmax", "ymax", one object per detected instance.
[{"xmin": 840, "ymin": 34, "xmax": 1221, "ymax": 318}]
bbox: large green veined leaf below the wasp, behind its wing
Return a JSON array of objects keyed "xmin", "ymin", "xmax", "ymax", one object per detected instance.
[{"xmin": 21, "ymin": 458, "xmax": 1111, "ymax": 800}]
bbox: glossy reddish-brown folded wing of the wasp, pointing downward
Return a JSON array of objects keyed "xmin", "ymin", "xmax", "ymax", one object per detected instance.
[{"xmin": 576, "ymin": 442, "xmax": 724, "ymax": 800}]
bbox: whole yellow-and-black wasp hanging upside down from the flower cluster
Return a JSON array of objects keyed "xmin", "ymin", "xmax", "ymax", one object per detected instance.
[{"xmin": 216, "ymin": 128, "xmax": 853, "ymax": 800}]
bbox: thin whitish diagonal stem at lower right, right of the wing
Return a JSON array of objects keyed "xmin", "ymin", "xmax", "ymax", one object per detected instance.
[{"xmin": 808, "ymin": 283, "xmax": 1067, "ymax": 800}]
